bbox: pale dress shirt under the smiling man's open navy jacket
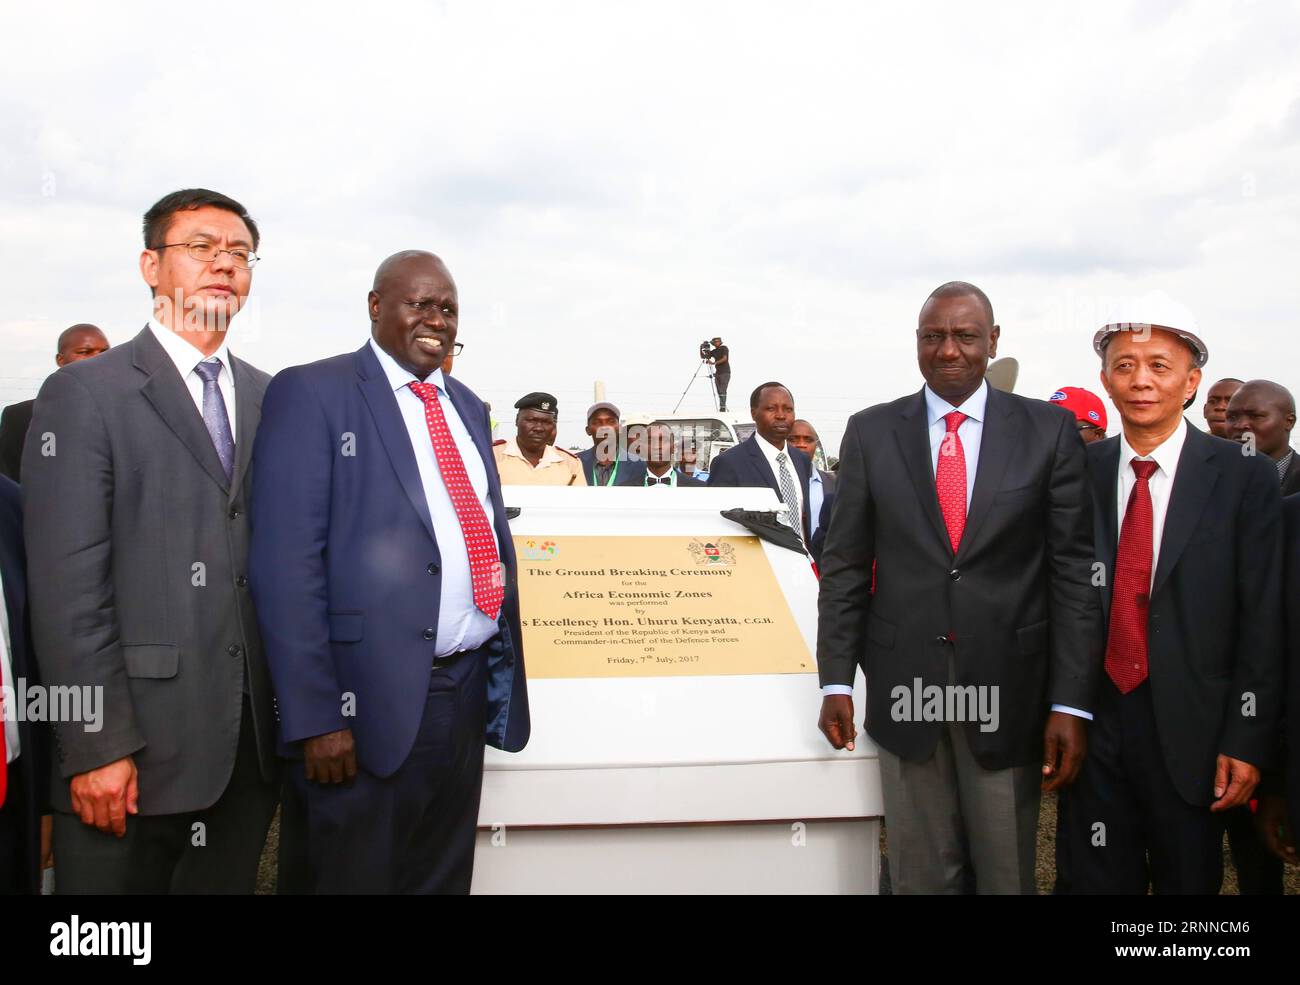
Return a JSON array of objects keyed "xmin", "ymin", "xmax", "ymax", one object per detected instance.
[{"xmin": 371, "ymin": 339, "xmax": 501, "ymax": 656}]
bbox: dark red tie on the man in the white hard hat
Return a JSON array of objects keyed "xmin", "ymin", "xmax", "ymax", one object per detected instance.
[{"xmin": 1106, "ymin": 459, "xmax": 1156, "ymax": 694}]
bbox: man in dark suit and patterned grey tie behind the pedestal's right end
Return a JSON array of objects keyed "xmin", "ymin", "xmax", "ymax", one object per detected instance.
[{"xmin": 709, "ymin": 382, "xmax": 813, "ymax": 544}]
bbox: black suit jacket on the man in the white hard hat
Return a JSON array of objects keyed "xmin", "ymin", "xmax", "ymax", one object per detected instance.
[{"xmin": 1088, "ymin": 426, "xmax": 1284, "ymax": 806}]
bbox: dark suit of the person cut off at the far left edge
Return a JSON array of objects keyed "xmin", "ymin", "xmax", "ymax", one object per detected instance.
[{"xmin": 0, "ymin": 478, "xmax": 49, "ymax": 893}]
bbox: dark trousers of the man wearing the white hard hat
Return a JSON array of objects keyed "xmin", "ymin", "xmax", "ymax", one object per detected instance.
[{"xmin": 1057, "ymin": 677, "xmax": 1223, "ymax": 895}]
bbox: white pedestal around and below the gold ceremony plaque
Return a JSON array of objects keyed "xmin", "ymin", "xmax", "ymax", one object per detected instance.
[{"xmin": 473, "ymin": 486, "xmax": 884, "ymax": 894}]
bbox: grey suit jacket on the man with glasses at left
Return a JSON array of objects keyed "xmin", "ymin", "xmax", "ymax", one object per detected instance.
[{"xmin": 22, "ymin": 327, "xmax": 276, "ymax": 815}]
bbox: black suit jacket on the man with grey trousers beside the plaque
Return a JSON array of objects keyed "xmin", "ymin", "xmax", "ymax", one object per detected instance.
[{"xmin": 818, "ymin": 389, "xmax": 1102, "ymax": 769}]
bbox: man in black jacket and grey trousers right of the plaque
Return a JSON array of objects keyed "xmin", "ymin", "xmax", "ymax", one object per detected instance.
[{"xmin": 818, "ymin": 282, "xmax": 1101, "ymax": 893}]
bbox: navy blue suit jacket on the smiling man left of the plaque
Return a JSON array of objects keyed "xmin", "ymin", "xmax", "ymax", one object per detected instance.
[{"xmin": 248, "ymin": 343, "xmax": 529, "ymax": 776}]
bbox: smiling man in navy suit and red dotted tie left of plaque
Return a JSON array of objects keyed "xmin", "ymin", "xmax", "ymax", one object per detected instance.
[{"xmin": 248, "ymin": 251, "xmax": 529, "ymax": 893}]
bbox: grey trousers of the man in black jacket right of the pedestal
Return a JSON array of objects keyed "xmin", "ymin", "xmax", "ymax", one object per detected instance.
[{"xmin": 880, "ymin": 723, "xmax": 1041, "ymax": 895}]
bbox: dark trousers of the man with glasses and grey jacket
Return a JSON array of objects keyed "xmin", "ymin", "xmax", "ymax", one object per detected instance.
[{"xmin": 55, "ymin": 695, "xmax": 278, "ymax": 895}]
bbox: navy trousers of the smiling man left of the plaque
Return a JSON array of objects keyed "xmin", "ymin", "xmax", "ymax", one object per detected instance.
[{"xmin": 286, "ymin": 646, "xmax": 489, "ymax": 894}]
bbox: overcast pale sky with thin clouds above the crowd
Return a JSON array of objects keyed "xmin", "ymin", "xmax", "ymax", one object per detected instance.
[{"xmin": 0, "ymin": 0, "xmax": 1300, "ymax": 452}]
